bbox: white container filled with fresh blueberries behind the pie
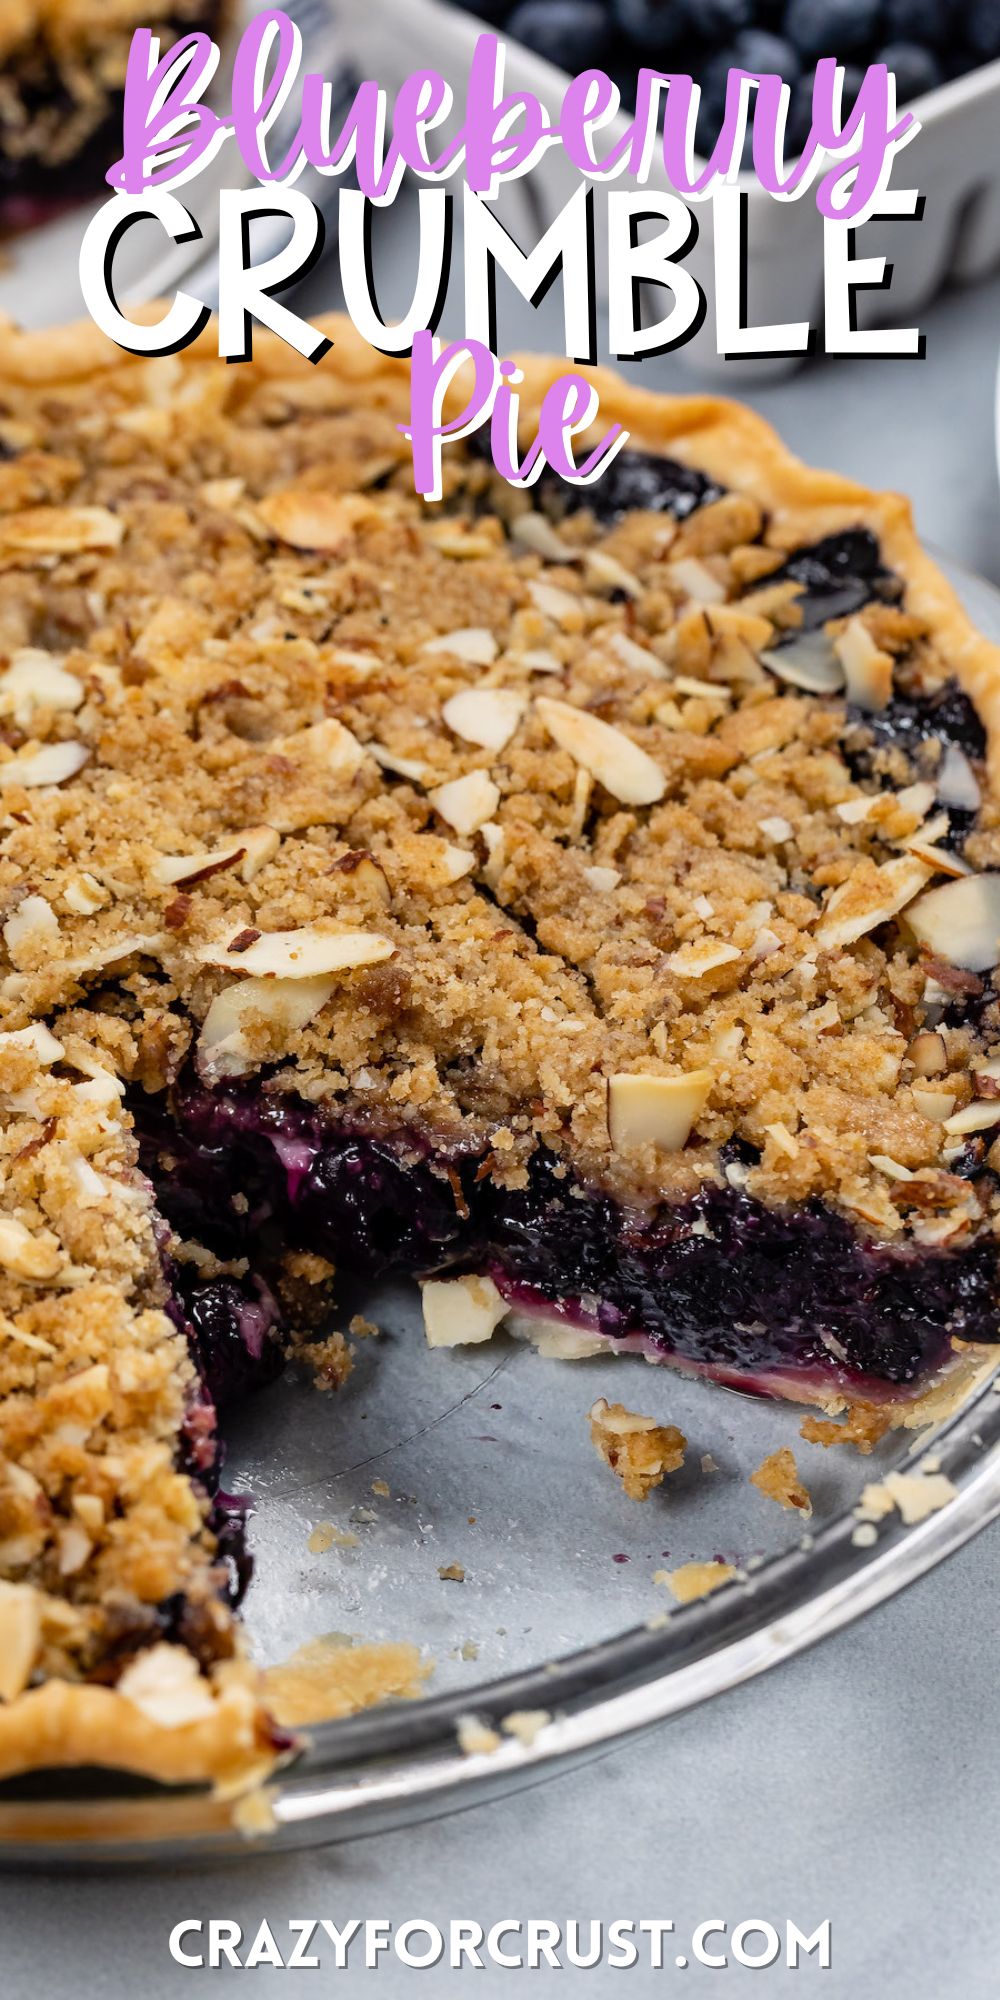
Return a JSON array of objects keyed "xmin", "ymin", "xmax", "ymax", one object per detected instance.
[{"xmin": 356, "ymin": 0, "xmax": 1000, "ymax": 380}]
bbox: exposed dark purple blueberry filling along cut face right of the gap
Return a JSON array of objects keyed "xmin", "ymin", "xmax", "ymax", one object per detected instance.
[{"xmin": 135, "ymin": 1082, "xmax": 1000, "ymax": 1386}]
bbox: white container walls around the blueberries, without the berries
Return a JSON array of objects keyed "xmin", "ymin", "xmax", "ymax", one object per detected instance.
[{"xmin": 344, "ymin": 0, "xmax": 1000, "ymax": 380}]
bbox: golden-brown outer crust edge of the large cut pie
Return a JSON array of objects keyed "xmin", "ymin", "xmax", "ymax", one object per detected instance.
[{"xmin": 0, "ymin": 310, "xmax": 1000, "ymax": 1790}]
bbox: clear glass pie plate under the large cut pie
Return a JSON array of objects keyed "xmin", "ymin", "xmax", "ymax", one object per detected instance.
[{"xmin": 0, "ymin": 562, "xmax": 1000, "ymax": 1866}]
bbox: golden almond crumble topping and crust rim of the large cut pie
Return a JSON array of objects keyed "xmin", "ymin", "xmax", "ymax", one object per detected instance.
[{"xmin": 0, "ymin": 320, "xmax": 1000, "ymax": 1784}]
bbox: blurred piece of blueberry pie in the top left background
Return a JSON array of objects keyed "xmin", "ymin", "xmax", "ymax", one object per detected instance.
[{"xmin": 0, "ymin": 0, "xmax": 228, "ymax": 232}]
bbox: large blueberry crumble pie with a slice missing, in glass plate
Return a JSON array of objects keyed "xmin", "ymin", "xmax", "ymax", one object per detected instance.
[{"xmin": 0, "ymin": 322, "xmax": 1000, "ymax": 1780}]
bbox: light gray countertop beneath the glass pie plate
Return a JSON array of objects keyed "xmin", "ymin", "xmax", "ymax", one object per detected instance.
[{"xmin": 0, "ymin": 250, "xmax": 1000, "ymax": 2000}]
